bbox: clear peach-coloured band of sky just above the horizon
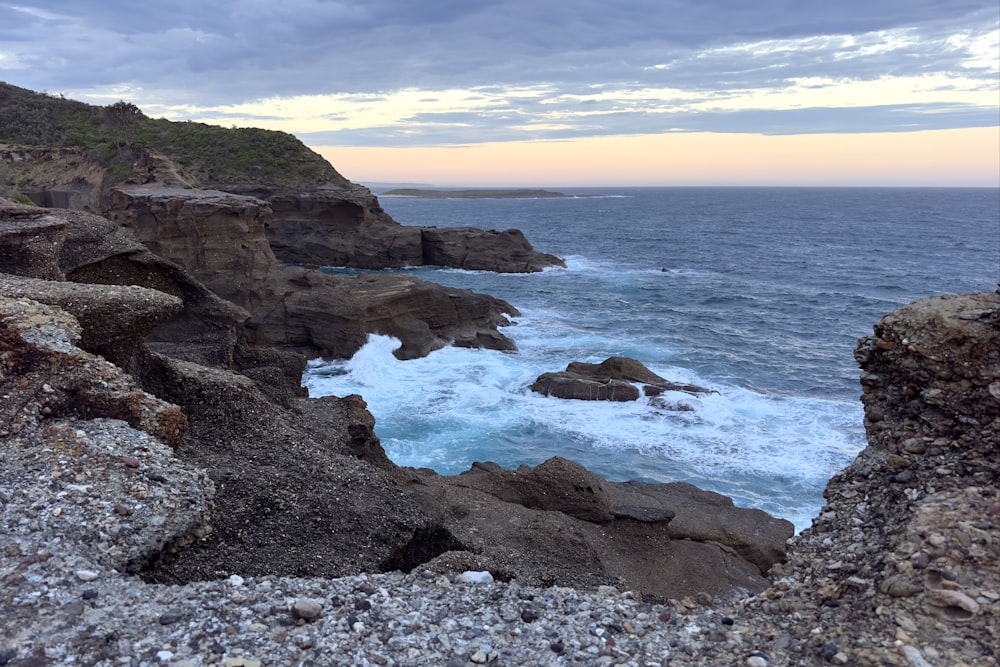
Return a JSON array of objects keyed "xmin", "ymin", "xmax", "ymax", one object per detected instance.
[{"xmin": 313, "ymin": 127, "xmax": 1000, "ymax": 187}]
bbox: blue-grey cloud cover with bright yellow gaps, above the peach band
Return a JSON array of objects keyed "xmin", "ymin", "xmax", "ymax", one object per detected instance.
[{"xmin": 0, "ymin": 0, "xmax": 1000, "ymax": 145}]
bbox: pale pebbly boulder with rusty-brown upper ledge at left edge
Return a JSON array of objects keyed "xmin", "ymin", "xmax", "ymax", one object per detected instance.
[{"xmin": 0, "ymin": 296, "xmax": 214, "ymax": 576}]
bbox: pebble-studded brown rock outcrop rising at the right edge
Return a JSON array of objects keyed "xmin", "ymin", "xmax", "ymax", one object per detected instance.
[{"xmin": 756, "ymin": 293, "xmax": 1000, "ymax": 667}]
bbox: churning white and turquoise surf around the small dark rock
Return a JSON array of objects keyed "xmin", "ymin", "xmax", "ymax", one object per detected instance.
[{"xmin": 306, "ymin": 335, "xmax": 863, "ymax": 527}]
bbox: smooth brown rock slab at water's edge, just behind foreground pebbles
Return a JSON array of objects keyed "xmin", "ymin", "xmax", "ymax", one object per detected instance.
[{"xmin": 397, "ymin": 458, "xmax": 792, "ymax": 600}]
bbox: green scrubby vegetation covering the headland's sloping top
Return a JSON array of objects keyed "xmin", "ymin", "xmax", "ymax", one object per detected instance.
[{"xmin": 0, "ymin": 81, "xmax": 349, "ymax": 187}]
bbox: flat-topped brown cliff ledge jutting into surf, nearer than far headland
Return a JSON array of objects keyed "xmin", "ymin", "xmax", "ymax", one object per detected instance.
[{"xmin": 109, "ymin": 186, "xmax": 518, "ymax": 359}]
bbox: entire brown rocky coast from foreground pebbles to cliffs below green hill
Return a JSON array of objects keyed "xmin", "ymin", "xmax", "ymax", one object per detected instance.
[{"xmin": 0, "ymin": 140, "xmax": 1000, "ymax": 667}]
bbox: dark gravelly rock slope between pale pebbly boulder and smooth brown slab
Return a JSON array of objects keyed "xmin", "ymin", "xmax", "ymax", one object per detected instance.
[{"xmin": 137, "ymin": 355, "xmax": 436, "ymax": 583}]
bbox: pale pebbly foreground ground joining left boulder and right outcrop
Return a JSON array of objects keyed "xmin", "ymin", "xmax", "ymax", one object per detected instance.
[{"xmin": 0, "ymin": 284, "xmax": 1000, "ymax": 667}]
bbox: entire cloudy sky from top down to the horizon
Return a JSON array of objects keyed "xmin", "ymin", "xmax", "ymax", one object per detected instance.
[{"xmin": 0, "ymin": 0, "xmax": 1000, "ymax": 187}]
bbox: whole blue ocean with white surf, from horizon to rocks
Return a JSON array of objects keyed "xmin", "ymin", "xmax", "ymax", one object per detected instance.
[{"xmin": 304, "ymin": 187, "xmax": 1000, "ymax": 530}]
